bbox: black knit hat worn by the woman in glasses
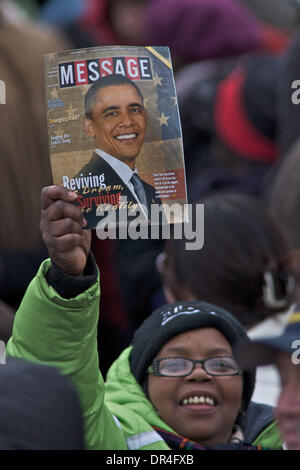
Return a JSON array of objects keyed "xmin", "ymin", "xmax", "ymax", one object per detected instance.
[{"xmin": 130, "ymin": 301, "xmax": 255, "ymax": 410}]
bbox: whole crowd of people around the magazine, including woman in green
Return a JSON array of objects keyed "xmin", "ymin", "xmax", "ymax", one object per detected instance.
[{"xmin": 0, "ymin": 0, "xmax": 300, "ymax": 450}]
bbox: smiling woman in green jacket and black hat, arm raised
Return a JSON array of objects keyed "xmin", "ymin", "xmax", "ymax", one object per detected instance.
[{"xmin": 7, "ymin": 186, "xmax": 282, "ymax": 450}]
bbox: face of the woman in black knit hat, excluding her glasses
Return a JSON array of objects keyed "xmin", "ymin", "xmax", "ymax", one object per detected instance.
[{"xmin": 148, "ymin": 328, "xmax": 243, "ymax": 445}]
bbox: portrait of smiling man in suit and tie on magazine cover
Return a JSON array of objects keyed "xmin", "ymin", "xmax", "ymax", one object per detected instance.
[{"xmin": 76, "ymin": 75, "xmax": 161, "ymax": 225}]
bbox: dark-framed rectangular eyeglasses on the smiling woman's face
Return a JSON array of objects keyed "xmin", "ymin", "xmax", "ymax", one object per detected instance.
[{"xmin": 148, "ymin": 356, "xmax": 243, "ymax": 377}]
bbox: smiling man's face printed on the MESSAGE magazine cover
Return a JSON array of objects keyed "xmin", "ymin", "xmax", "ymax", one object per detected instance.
[{"xmin": 85, "ymin": 84, "xmax": 147, "ymax": 169}]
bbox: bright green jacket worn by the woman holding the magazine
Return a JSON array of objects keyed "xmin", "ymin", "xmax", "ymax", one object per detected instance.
[{"xmin": 7, "ymin": 260, "xmax": 281, "ymax": 450}]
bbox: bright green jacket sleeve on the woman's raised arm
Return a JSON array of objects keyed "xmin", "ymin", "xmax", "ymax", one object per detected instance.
[{"xmin": 6, "ymin": 260, "xmax": 127, "ymax": 449}]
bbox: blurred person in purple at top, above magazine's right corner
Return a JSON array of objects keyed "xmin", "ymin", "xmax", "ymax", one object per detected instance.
[{"xmin": 144, "ymin": 0, "xmax": 287, "ymax": 70}]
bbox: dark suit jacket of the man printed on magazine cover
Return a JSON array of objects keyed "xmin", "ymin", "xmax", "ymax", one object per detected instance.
[{"xmin": 74, "ymin": 153, "xmax": 161, "ymax": 228}]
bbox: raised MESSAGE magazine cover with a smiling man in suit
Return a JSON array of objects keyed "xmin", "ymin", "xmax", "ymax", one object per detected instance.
[{"xmin": 44, "ymin": 46, "xmax": 187, "ymax": 228}]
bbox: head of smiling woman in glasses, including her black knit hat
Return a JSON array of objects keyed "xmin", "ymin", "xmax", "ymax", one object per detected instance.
[{"xmin": 126, "ymin": 302, "xmax": 259, "ymax": 446}]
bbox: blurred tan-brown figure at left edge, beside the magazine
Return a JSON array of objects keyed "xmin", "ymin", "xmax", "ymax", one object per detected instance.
[{"xmin": 0, "ymin": 2, "xmax": 69, "ymax": 341}]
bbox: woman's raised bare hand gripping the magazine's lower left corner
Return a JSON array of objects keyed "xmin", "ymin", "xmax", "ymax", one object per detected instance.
[{"xmin": 40, "ymin": 186, "xmax": 91, "ymax": 276}]
